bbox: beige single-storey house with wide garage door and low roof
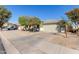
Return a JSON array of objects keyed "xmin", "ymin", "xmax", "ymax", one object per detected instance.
[{"xmin": 40, "ymin": 20, "xmax": 59, "ymax": 33}]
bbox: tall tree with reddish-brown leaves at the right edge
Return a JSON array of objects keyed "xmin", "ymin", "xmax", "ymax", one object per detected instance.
[{"xmin": 66, "ymin": 8, "xmax": 79, "ymax": 30}]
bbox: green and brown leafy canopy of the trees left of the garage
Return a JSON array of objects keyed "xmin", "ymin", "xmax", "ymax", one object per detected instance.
[{"xmin": 19, "ymin": 16, "xmax": 41, "ymax": 26}]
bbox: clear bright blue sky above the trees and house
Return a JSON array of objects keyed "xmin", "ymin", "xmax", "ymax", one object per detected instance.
[{"xmin": 5, "ymin": 5, "xmax": 79, "ymax": 23}]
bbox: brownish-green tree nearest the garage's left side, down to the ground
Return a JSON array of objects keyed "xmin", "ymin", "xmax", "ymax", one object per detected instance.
[{"xmin": 29, "ymin": 17, "xmax": 41, "ymax": 31}]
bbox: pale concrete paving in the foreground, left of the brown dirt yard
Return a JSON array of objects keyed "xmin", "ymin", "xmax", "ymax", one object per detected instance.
[{"xmin": 0, "ymin": 31, "xmax": 79, "ymax": 54}]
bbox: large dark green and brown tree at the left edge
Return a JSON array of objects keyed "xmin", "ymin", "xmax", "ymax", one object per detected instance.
[{"xmin": 0, "ymin": 6, "xmax": 12, "ymax": 28}]
